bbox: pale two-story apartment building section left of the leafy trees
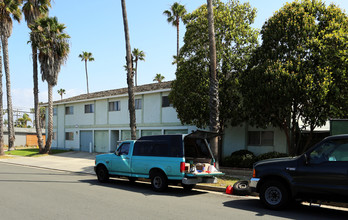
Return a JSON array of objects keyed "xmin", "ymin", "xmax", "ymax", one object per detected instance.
[{"xmin": 47, "ymin": 82, "xmax": 197, "ymax": 152}]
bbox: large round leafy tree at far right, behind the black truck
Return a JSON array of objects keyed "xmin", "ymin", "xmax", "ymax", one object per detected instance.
[{"xmin": 241, "ymin": 0, "xmax": 348, "ymax": 155}]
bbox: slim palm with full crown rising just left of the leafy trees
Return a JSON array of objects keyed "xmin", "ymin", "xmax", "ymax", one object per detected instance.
[{"xmin": 163, "ymin": 2, "xmax": 186, "ymax": 60}]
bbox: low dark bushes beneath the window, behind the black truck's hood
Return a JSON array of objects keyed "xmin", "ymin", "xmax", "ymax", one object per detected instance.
[{"xmin": 221, "ymin": 150, "xmax": 289, "ymax": 168}]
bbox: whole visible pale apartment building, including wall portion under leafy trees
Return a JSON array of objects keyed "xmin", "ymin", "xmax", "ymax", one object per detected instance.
[{"xmin": 47, "ymin": 82, "xmax": 287, "ymax": 157}]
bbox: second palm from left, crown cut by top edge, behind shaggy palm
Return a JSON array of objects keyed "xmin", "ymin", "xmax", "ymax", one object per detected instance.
[{"xmin": 22, "ymin": 0, "xmax": 51, "ymax": 152}]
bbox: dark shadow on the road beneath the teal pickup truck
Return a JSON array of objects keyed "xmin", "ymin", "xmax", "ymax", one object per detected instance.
[{"xmin": 80, "ymin": 178, "xmax": 207, "ymax": 197}]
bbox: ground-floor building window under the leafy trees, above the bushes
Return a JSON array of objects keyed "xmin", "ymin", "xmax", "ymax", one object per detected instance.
[{"xmin": 248, "ymin": 131, "xmax": 274, "ymax": 146}]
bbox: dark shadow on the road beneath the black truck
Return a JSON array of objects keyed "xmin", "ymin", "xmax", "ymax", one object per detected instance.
[{"xmin": 223, "ymin": 199, "xmax": 348, "ymax": 220}]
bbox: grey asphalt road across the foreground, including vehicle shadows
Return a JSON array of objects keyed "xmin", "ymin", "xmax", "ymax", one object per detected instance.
[{"xmin": 0, "ymin": 163, "xmax": 348, "ymax": 220}]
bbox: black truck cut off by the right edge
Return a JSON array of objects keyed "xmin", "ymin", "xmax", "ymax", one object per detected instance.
[{"xmin": 249, "ymin": 135, "xmax": 348, "ymax": 209}]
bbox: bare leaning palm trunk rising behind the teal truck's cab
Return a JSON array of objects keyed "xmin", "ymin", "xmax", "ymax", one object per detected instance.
[{"xmin": 121, "ymin": 0, "xmax": 137, "ymax": 140}]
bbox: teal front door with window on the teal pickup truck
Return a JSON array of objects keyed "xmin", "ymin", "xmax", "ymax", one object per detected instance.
[{"xmin": 110, "ymin": 142, "xmax": 131, "ymax": 176}]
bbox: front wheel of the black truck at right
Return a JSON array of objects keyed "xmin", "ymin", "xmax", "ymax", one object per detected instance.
[{"xmin": 260, "ymin": 180, "xmax": 289, "ymax": 210}]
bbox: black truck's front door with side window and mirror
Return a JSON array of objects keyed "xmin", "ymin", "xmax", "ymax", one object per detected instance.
[{"xmin": 294, "ymin": 139, "xmax": 348, "ymax": 196}]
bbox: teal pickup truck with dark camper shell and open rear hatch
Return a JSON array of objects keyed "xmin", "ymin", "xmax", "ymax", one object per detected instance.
[{"xmin": 94, "ymin": 131, "xmax": 223, "ymax": 191}]
